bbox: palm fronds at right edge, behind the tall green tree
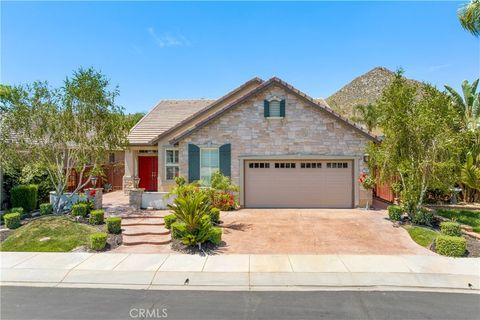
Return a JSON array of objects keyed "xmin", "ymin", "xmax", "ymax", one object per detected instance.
[{"xmin": 445, "ymin": 79, "xmax": 480, "ymax": 131}]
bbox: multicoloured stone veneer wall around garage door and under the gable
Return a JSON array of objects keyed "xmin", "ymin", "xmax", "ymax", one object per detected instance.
[{"xmin": 179, "ymin": 87, "xmax": 371, "ymax": 206}]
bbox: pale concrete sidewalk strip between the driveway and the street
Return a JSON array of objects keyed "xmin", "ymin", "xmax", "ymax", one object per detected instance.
[{"xmin": 0, "ymin": 252, "xmax": 480, "ymax": 293}]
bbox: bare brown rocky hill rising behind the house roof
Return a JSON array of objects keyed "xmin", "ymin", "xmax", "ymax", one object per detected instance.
[{"xmin": 326, "ymin": 67, "xmax": 419, "ymax": 118}]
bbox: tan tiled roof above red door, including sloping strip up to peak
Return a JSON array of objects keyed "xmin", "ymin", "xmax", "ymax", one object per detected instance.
[{"xmin": 128, "ymin": 77, "xmax": 263, "ymax": 145}]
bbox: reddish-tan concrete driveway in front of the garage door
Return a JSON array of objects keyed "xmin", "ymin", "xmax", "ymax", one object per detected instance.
[{"xmin": 218, "ymin": 209, "xmax": 434, "ymax": 255}]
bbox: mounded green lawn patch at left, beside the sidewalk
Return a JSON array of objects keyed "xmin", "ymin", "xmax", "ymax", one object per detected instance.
[{"xmin": 0, "ymin": 216, "xmax": 98, "ymax": 252}]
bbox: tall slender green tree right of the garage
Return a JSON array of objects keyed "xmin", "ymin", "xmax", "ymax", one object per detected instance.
[{"xmin": 368, "ymin": 72, "xmax": 459, "ymax": 217}]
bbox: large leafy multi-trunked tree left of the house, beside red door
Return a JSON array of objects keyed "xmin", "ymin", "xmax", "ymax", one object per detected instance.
[{"xmin": 0, "ymin": 68, "xmax": 128, "ymax": 213}]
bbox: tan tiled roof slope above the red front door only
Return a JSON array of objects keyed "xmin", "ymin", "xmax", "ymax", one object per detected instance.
[{"xmin": 128, "ymin": 99, "xmax": 215, "ymax": 144}]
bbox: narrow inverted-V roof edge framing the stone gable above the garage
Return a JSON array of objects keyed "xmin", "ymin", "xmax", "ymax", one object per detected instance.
[{"xmin": 170, "ymin": 77, "xmax": 379, "ymax": 144}]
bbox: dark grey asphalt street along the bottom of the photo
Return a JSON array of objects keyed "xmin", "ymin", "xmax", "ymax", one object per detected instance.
[{"xmin": 0, "ymin": 287, "xmax": 480, "ymax": 320}]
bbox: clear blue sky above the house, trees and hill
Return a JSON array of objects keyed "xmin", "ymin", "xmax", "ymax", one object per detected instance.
[{"xmin": 1, "ymin": 1, "xmax": 480, "ymax": 112}]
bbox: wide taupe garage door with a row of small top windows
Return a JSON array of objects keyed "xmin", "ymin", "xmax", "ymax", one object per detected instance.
[{"xmin": 244, "ymin": 160, "xmax": 353, "ymax": 208}]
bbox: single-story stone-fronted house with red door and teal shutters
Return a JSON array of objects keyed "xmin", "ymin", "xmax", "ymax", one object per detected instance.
[{"xmin": 123, "ymin": 77, "xmax": 378, "ymax": 208}]
